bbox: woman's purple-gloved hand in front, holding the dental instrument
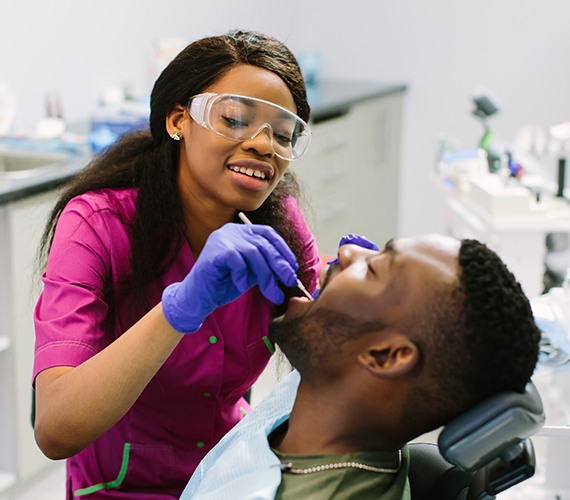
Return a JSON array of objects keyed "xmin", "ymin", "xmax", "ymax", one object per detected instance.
[{"xmin": 158, "ymin": 223, "xmax": 298, "ymax": 333}]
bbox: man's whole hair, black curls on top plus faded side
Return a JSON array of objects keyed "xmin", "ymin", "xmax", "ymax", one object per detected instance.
[{"xmin": 408, "ymin": 239, "xmax": 540, "ymax": 427}]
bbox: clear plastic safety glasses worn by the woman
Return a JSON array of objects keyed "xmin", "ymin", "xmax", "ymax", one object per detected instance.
[{"xmin": 188, "ymin": 93, "xmax": 311, "ymax": 161}]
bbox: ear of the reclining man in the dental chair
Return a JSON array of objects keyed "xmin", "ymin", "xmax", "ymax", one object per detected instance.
[{"xmin": 358, "ymin": 334, "xmax": 420, "ymax": 377}]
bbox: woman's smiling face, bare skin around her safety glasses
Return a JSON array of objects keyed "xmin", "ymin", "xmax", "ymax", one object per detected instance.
[{"xmin": 173, "ymin": 65, "xmax": 297, "ymax": 213}]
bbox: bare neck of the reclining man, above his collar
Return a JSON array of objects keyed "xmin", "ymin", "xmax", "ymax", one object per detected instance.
[{"xmin": 270, "ymin": 383, "xmax": 405, "ymax": 455}]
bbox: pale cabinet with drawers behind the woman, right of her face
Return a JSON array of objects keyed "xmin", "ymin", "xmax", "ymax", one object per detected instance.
[{"xmin": 290, "ymin": 91, "xmax": 404, "ymax": 255}]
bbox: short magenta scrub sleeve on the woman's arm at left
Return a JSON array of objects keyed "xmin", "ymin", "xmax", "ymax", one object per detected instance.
[{"xmin": 33, "ymin": 201, "xmax": 115, "ymax": 380}]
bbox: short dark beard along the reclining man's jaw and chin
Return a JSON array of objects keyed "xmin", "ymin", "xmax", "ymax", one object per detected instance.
[{"xmin": 269, "ymin": 309, "xmax": 381, "ymax": 375}]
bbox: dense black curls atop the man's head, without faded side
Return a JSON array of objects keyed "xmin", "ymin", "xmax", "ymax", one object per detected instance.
[{"xmin": 452, "ymin": 240, "xmax": 540, "ymax": 397}]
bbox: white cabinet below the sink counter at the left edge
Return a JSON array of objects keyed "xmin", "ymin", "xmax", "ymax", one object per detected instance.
[{"xmin": 0, "ymin": 190, "xmax": 58, "ymax": 492}]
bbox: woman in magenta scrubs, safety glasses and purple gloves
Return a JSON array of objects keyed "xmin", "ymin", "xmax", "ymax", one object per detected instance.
[{"xmin": 33, "ymin": 31, "xmax": 320, "ymax": 500}]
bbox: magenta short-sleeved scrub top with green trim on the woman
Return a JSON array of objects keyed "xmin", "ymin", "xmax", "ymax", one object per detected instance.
[{"xmin": 33, "ymin": 189, "xmax": 321, "ymax": 500}]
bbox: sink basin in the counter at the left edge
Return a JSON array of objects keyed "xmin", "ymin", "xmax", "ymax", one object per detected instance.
[{"xmin": 0, "ymin": 149, "xmax": 71, "ymax": 179}]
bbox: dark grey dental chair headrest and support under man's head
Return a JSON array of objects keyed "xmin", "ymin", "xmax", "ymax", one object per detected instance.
[{"xmin": 409, "ymin": 382, "xmax": 544, "ymax": 500}]
